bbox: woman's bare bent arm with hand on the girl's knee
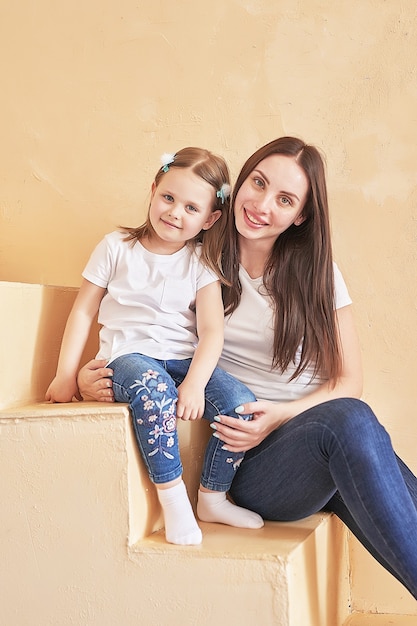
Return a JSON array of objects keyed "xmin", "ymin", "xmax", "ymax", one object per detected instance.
[{"xmin": 210, "ymin": 305, "xmax": 362, "ymax": 452}]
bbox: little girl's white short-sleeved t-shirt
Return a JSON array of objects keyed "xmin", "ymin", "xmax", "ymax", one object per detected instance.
[{"xmin": 82, "ymin": 231, "xmax": 217, "ymax": 361}]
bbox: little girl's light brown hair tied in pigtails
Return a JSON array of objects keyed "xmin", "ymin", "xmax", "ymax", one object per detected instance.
[{"xmin": 122, "ymin": 147, "xmax": 230, "ymax": 282}]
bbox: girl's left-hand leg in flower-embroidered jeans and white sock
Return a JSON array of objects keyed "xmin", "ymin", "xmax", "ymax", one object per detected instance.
[{"xmin": 109, "ymin": 354, "xmax": 202, "ymax": 545}]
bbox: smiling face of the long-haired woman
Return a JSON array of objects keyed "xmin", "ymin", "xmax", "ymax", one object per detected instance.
[{"xmin": 234, "ymin": 154, "xmax": 309, "ymax": 247}]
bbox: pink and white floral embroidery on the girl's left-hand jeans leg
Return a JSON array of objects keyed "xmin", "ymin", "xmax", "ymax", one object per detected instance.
[{"xmin": 130, "ymin": 369, "xmax": 177, "ymax": 460}]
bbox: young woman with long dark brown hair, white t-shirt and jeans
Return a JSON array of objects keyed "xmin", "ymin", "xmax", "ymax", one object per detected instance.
[{"xmin": 79, "ymin": 137, "xmax": 417, "ymax": 598}]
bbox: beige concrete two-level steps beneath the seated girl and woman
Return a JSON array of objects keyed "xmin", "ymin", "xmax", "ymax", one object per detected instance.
[{"xmin": 0, "ymin": 403, "xmax": 348, "ymax": 626}]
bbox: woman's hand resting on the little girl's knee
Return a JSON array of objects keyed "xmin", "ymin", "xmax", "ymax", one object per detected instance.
[{"xmin": 211, "ymin": 400, "xmax": 289, "ymax": 452}]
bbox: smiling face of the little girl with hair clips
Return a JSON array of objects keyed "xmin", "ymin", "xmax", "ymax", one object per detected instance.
[{"xmin": 149, "ymin": 167, "xmax": 221, "ymax": 254}]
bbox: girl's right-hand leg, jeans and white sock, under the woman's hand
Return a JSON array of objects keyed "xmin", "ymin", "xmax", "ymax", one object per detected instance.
[{"xmin": 193, "ymin": 368, "xmax": 264, "ymax": 528}]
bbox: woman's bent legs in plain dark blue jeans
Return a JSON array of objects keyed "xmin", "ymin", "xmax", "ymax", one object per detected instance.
[{"xmin": 231, "ymin": 398, "xmax": 417, "ymax": 597}]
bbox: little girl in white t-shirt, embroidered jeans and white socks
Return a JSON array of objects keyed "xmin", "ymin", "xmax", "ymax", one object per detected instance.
[{"xmin": 46, "ymin": 148, "xmax": 263, "ymax": 545}]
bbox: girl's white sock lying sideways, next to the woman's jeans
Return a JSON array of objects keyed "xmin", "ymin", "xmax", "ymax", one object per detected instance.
[{"xmin": 197, "ymin": 490, "xmax": 264, "ymax": 528}]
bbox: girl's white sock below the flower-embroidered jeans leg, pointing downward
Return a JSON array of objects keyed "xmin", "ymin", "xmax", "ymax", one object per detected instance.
[{"xmin": 157, "ymin": 481, "xmax": 203, "ymax": 546}]
